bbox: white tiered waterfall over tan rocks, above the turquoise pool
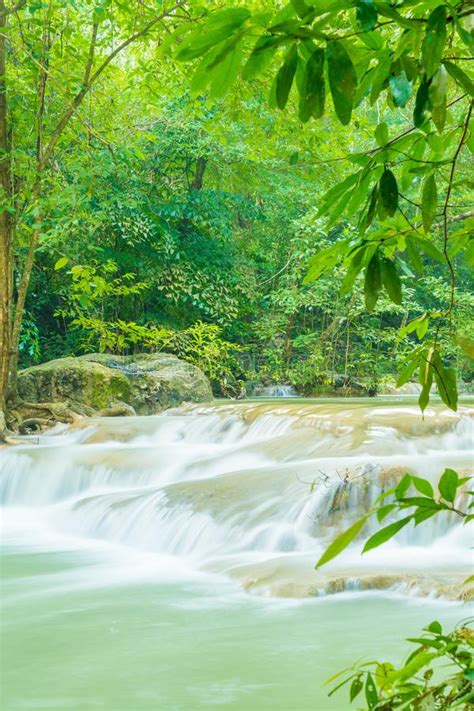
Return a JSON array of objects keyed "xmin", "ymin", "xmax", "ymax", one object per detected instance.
[{"xmin": 0, "ymin": 400, "xmax": 473, "ymax": 596}]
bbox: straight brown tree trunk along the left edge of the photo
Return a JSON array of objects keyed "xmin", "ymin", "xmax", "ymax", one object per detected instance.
[{"xmin": 0, "ymin": 0, "xmax": 13, "ymax": 422}]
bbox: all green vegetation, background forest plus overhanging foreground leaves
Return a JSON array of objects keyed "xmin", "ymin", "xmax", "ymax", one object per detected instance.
[{"xmin": 0, "ymin": 0, "xmax": 474, "ymax": 709}]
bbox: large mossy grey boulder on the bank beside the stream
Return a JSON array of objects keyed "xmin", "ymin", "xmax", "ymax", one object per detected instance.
[{"xmin": 18, "ymin": 353, "xmax": 212, "ymax": 415}]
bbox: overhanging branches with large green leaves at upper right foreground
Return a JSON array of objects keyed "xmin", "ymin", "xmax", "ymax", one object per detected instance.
[{"xmin": 175, "ymin": 0, "xmax": 474, "ymax": 410}]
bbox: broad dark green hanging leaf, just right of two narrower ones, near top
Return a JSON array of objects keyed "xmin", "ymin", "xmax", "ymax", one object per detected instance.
[{"xmin": 327, "ymin": 41, "xmax": 357, "ymax": 126}]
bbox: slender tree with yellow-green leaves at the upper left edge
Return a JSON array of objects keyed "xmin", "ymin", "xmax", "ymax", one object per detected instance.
[{"xmin": 0, "ymin": 0, "xmax": 192, "ymax": 422}]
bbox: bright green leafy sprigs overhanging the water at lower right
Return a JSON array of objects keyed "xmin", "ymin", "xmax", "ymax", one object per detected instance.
[{"xmin": 316, "ymin": 469, "xmax": 474, "ymax": 711}]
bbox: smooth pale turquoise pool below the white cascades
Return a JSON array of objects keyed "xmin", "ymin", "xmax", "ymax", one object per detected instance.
[{"xmin": 2, "ymin": 549, "xmax": 466, "ymax": 711}]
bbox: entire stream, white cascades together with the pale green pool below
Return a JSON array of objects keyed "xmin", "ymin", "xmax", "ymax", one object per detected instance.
[{"xmin": 0, "ymin": 399, "xmax": 473, "ymax": 711}]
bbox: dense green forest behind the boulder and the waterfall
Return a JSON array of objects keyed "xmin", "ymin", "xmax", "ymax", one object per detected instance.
[{"xmin": 2, "ymin": 0, "xmax": 473, "ymax": 412}]
